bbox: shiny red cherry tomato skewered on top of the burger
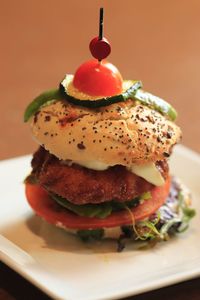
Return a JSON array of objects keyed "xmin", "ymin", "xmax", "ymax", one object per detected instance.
[{"xmin": 73, "ymin": 59, "xmax": 123, "ymax": 96}]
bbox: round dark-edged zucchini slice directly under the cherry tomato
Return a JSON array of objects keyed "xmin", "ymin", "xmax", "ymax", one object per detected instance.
[{"xmin": 60, "ymin": 75, "xmax": 142, "ymax": 108}]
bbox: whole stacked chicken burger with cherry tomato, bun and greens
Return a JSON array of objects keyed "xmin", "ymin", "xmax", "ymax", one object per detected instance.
[{"xmin": 24, "ymin": 22, "xmax": 195, "ymax": 251}]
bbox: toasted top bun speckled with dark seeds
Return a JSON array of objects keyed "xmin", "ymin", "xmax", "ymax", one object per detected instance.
[{"xmin": 30, "ymin": 100, "xmax": 181, "ymax": 167}]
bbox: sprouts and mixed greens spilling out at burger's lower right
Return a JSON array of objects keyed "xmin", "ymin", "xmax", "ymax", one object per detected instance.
[{"xmin": 118, "ymin": 178, "xmax": 196, "ymax": 251}]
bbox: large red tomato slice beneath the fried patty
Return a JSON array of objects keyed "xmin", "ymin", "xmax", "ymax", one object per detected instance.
[{"xmin": 26, "ymin": 178, "xmax": 170, "ymax": 229}]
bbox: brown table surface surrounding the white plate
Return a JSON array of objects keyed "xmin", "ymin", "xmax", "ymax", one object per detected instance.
[{"xmin": 0, "ymin": 0, "xmax": 200, "ymax": 300}]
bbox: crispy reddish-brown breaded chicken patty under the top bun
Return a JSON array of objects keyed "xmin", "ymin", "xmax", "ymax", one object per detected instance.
[{"xmin": 32, "ymin": 147, "xmax": 168, "ymax": 204}]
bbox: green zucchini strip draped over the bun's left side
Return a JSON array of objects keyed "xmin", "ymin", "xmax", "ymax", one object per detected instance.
[{"xmin": 24, "ymin": 89, "xmax": 62, "ymax": 122}]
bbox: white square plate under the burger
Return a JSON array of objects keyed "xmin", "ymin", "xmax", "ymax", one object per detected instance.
[{"xmin": 0, "ymin": 146, "xmax": 200, "ymax": 300}]
